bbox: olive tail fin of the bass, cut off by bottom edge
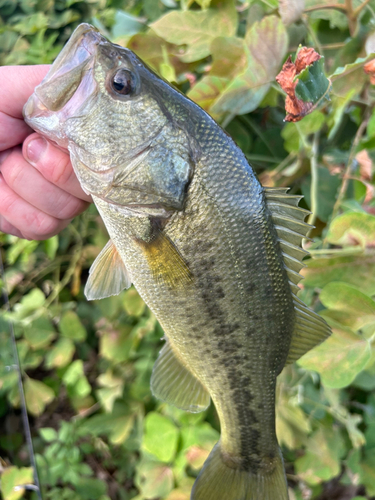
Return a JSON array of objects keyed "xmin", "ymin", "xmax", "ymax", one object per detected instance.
[{"xmin": 190, "ymin": 442, "xmax": 289, "ymax": 500}]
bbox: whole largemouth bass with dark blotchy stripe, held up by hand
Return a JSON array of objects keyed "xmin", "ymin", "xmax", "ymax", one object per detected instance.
[{"xmin": 24, "ymin": 24, "xmax": 331, "ymax": 500}]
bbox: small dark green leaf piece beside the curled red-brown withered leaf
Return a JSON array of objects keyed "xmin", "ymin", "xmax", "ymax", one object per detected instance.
[{"xmin": 294, "ymin": 57, "xmax": 331, "ymax": 106}]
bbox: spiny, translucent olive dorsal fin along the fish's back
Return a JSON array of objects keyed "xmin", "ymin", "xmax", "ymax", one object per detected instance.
[{"xmin": 264, "ymin": 188, "xmax": 331, "ymax": 364}]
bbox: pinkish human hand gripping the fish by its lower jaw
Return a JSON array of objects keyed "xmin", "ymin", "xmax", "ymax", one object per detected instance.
[{"xmin": 0, "ymin": 65, "xmax": 91, "ymax": 240}]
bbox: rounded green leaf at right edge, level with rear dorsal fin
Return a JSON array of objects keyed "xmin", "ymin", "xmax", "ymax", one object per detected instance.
[{"xmin": 319, "ymin": 282, "xmax": 375, "ymax": 331}]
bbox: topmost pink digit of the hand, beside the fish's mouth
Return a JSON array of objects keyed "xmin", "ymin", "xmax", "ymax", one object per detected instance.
[{"xmin": 0, "ymin": 64, "xmax": 50, "ymax": 119}]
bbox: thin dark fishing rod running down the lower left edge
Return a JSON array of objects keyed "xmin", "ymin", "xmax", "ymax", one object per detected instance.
[{"xmin": 0, "ymin": 244, "xmax": 43, "ymax": 500}]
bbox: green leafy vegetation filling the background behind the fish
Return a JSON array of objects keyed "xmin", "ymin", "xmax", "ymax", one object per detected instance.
[{"xmin": 0, "ymin": 0, "xmax": 375, "ymax": 500}]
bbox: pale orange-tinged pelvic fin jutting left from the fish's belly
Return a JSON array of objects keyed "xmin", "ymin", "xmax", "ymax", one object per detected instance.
[{"xmin": 85, "ymin": 240, "xmax": 131, "ymax": 300}]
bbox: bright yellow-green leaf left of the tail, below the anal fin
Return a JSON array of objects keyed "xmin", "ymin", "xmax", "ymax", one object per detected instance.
[{"xmin": 142, "ymin": 412, "xmax": 179, "ymax": 463}]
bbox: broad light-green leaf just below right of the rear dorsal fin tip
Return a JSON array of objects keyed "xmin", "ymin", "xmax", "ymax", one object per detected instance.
[{"xmin": 298, "ymin": 318, "xmax": 371, "ymax": 389}]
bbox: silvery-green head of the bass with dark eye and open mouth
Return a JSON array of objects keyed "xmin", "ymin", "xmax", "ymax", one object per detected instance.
[{"xmin": 24, "ymin": 24, "xmax": 192, "ymax": 215}]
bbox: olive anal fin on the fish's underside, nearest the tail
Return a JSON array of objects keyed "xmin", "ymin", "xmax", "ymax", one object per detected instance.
[{"xmin": 151, "ymin": 340, "xmax": 210, "ymax": 413}]
